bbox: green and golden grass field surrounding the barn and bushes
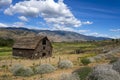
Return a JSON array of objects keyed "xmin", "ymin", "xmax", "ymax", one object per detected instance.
[{"xmin": 0, "ymin": 41, "xmax": 120, "ymax": 80}]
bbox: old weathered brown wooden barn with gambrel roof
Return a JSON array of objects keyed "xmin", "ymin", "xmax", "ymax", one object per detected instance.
[{"xmin": 13, "ymin": 36, "xmax": 52, "ymax": 59}]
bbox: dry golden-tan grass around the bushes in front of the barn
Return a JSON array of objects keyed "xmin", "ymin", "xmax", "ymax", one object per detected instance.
[{"xmin": 0, "ymin": 53, "xmax": 120, "ymax": 80}]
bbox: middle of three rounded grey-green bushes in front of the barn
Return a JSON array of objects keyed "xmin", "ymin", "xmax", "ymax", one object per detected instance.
[{"xmin": 35, "ymin": 64, "xmax": 56, "ymax": 74}]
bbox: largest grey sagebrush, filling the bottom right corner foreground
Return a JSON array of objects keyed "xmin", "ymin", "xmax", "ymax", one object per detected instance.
[{"xmin": 87, "ymin": 65, "xmax": 120, "ymax": 80}]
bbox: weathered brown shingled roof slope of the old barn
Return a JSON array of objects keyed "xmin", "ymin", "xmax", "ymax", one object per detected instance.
[{"xmin": 13, "ymin": 36, "xmax": 47, "ymax": 49}]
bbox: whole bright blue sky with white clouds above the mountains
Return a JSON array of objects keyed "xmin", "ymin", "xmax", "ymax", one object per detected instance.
[{"xmin": 0, "ymin": 0, "xmax": 120, "ymax": 38}]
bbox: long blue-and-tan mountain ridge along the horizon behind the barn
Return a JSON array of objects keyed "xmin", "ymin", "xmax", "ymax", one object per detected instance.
[{"xmin": 0, "ymin": 27, "xmax": 110, "ymax": 42}]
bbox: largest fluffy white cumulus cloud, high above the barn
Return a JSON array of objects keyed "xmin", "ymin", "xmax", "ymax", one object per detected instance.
[{"xmin": 4, "ymin": 0, "xmax": 81, "ymax": 28}]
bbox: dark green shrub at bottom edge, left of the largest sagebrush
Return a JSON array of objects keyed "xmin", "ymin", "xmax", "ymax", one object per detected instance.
[{"xmin": 73, "ymin": 67, "xmax": 92, "ymax": 80}]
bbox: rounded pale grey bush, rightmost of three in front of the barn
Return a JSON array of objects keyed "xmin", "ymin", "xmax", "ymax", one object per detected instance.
[{"xmin": 58, "ymin": 60, "xmax": 73, "ymax": 69}]
